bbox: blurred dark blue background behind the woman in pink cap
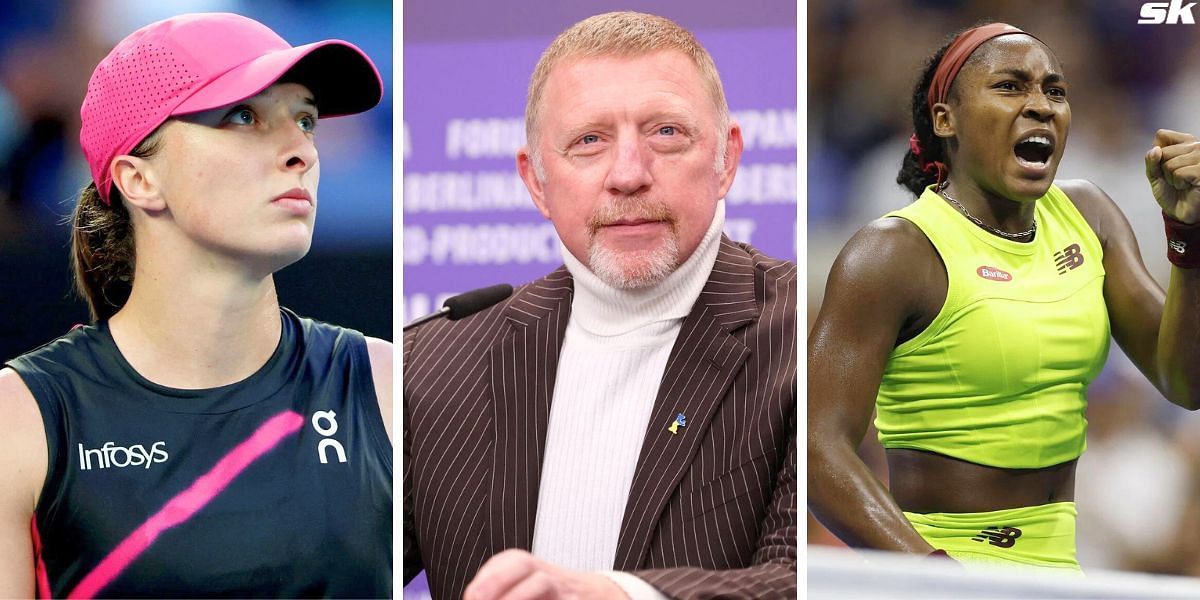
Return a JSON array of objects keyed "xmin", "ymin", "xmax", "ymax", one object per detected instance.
[{"xmin": 0, "ymin": 0, "xmax": 392, "ymax": 361}]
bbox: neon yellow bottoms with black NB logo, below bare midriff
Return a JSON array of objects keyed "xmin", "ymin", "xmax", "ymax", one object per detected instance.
[{"xmin": 904, "ymin": 502, "xmax": 1080, "ymax": 571}]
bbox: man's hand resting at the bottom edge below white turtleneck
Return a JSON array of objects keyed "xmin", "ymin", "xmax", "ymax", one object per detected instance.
[{"xmin": 462, "ymin": 550, "xmax": 629, "ymax": 600}]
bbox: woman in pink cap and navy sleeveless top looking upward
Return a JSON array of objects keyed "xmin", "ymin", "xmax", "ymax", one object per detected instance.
[{"xmin": 0, "ymin": 13, "xmax": 392, "ymax": 598}]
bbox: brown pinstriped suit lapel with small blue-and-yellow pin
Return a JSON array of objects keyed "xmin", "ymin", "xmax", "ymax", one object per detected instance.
[{"xmin": 613, "ymin": 235, "xmax": 758, "ymax": 570}]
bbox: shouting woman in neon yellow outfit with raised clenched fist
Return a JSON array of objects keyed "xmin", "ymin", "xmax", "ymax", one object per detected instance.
[{"xmin": 808, "ymin": 23, "xmax": 1200, "ymax": 570}]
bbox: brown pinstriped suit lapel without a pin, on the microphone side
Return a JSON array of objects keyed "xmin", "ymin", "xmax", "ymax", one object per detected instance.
[{"xmin": 488, "ymin": 266, "xmax": 572, "ymax": 554}]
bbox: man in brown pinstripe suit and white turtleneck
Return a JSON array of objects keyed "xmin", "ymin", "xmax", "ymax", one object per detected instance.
[{"xmin": 403, "ymin": 13, "xmax": 798, "ymax": 600}]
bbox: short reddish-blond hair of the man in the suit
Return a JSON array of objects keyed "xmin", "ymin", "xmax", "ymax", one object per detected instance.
[{"xmin": 526, "ymin": 11, "xmax": 730, "ymax": 166}]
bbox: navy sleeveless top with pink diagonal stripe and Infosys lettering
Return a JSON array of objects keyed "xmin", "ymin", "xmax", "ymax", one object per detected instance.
[{"xmin": 8, "ymin": 310, "xmax": 392, "ymax": 598}]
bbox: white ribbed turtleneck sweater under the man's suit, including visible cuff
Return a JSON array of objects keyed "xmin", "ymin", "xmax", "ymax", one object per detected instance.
[{"xmin": 533, "ymin": 202, "xmax": 725, "ymax": 598}]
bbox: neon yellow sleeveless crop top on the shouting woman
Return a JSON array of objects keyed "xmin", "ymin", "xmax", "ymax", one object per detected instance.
[{"xmin": 875, "ymin": 186, "xmax": 1109, "ymax": 468}]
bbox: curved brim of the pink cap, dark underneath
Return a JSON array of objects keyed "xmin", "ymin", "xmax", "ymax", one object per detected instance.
[{"xmin": 170, "ymin": 40, "xmax": 383, "ymax": 118}]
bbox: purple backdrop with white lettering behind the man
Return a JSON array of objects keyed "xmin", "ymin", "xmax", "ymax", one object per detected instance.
[{"xmin": 402, "ymin": 0, "xmax": 797, "ymax": 599}]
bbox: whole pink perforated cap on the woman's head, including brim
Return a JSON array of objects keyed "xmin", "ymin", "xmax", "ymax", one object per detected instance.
[{"xmin": 79, "ymin": 13, "xmax": 383, "ymax": 204}]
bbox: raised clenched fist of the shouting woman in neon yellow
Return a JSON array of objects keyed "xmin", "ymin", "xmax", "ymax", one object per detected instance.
[{"xmin": 1146, "ymin": 130, "xmax": 1200, "ymax": 223}]
